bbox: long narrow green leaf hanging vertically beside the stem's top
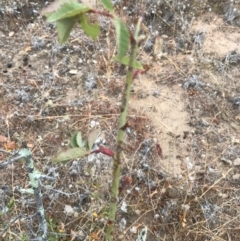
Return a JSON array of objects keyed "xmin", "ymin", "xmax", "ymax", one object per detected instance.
[{"xmin": 115, "ymin": 18, "xmax": 130, "ymax": 60}]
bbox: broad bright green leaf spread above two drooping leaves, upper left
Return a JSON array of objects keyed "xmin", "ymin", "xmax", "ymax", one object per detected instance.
[{"xmin": 44, "ymin": 1, "xmax": 91, "ymax": 23}]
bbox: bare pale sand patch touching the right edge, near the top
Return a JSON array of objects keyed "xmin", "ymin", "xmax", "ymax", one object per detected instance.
[{"xmin": 192, "ymin": 15, "xmax": 240, "ymax": 57}]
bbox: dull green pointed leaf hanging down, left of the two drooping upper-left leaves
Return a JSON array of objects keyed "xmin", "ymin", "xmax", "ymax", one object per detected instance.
[{"xmin": 57, "ymin": 17, "xmax": 77, "ymax": 44}]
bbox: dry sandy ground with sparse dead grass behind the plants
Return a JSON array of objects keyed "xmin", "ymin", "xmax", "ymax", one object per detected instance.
[{"xmin": 0, "ymin": 0, "xmax": 240, "ymax": 241}]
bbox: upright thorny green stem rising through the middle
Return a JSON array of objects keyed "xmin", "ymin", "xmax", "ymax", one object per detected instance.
[{"xmin": 106, "ymin": 17, "xmax": 142, "ymax": 241}]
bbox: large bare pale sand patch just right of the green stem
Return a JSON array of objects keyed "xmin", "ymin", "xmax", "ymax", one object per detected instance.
[{"xmin": 130, "ymin": 76, "xmax": 190, "ymax": 177}]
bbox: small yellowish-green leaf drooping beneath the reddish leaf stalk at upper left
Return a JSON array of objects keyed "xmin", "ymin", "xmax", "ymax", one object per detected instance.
[{"xmin": 79, "ymin": 14, "xmax": 100, "ymax": 40}]
